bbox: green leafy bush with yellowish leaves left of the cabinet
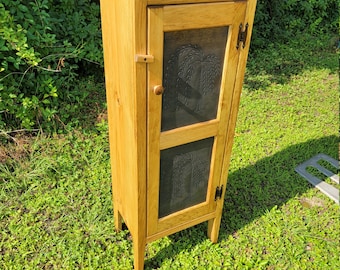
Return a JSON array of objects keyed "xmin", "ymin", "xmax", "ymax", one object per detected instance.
[{"xmin": 0, "ymin": 0, "xmax": 102, "ymax": 129}]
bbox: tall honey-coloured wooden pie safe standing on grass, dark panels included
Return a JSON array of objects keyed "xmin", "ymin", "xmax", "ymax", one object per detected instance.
[{"xmin": 101, "ymin": 0, "xmax": 256, "ymax": 269}]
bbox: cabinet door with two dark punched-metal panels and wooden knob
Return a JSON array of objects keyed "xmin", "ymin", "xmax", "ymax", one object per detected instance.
[{"xmin": 147, "ymin": 1, "xmax": 246, "ymax": 237}]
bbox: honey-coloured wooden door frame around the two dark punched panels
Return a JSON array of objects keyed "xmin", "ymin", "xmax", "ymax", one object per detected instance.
[{"xmin": 147, "ymin": 2, "xmax": 247, "ymax": 237}]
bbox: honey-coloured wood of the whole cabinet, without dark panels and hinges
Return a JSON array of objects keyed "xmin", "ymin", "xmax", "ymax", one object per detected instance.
[{"xmin": 101, "ymin": 0, "xmax": 256, "ymax": 269}]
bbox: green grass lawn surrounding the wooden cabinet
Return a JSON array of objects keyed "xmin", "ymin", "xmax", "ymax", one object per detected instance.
[{"xmin": 0, "ymin": 34, "xmax": 340, "ymax": 270}]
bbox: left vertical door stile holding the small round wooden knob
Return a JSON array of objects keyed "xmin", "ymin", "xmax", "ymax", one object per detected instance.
[{"xmin": 147, "ymin": 8, "xmax": 163, "ymax": 235}]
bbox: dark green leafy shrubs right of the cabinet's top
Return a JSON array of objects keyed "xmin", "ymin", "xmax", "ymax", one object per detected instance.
[{"xmin": 252, "ymin": 0, "xmax": 339, "ymax": 50}]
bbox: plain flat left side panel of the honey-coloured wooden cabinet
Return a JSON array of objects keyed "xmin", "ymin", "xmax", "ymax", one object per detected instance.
[{"xmin": 101, "ymin": 0, "xmax": 146, "ymax": 234}]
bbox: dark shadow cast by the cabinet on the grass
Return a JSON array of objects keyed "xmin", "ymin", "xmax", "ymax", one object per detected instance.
[{"xmin": 145, "ymin": 136, "xmax": 338, "ymax": 269}]
